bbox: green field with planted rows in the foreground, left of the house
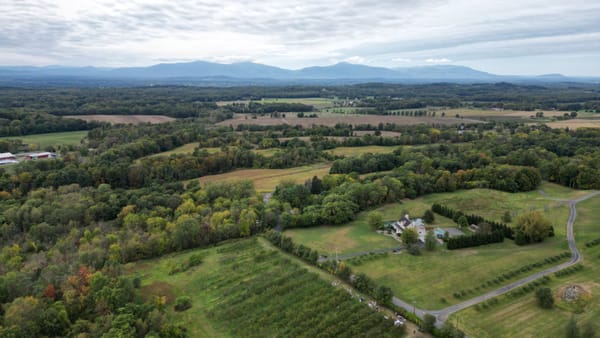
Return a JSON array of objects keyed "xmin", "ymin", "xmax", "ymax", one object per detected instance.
[{"xmin": 127, "ymin": 238, "xmax": 406, "ymax": 337}]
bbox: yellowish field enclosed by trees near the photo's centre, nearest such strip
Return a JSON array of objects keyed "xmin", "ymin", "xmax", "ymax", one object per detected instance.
[{"xmin": 199, "ymin": 164, "xmax": 330, "ymax": 192}]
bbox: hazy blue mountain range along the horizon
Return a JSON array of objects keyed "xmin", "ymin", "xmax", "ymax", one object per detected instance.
[{"xmin": 0, "ymin": 61, "xmax": 600, "ymax": 85}]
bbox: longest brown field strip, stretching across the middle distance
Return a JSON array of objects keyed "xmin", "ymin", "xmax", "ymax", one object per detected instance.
[{"xmin": 218, "ymin": 114, "xmax": 482, "ymax": 128}]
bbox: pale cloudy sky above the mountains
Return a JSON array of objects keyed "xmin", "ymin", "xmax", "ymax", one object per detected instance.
[{"xmin": 0, "ymin": 0, "xmax": 600, "ymax": 76}]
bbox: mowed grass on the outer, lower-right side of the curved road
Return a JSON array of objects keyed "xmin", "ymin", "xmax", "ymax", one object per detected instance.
[{"xmin": 450, "ymin": 196, "xmax": 600, "ymax": 337}]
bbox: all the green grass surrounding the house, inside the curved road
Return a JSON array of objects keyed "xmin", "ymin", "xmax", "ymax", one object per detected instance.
[{"xmin": 285, "ymin": 183, "xmax": 600, "ymax": 309}]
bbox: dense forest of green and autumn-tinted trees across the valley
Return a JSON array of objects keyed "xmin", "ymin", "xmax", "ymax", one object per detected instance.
[{"xmin": 0, "ymin": 84, "xmax": 600, "ymax": 337}]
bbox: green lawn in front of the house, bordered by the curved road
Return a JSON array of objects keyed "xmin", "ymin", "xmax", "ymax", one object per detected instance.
[{"xmin": 354, "ymin": 238, "xmax": 564, "ymax": 309}]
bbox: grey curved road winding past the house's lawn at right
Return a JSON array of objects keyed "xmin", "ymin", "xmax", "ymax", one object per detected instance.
[{"xmin": 392, "ymin": 191, "xmax": 600, "ymax": 326}]
